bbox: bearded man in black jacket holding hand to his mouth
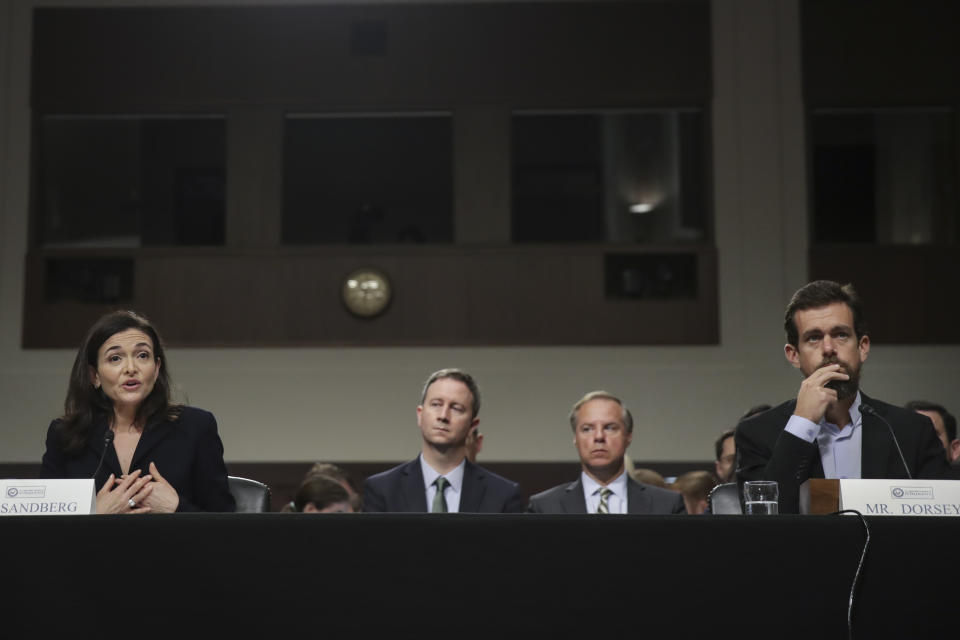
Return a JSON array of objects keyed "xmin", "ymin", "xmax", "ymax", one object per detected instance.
[{"xmin": 736, "ymin": 280, "xmax": 949, "ymax": 513}]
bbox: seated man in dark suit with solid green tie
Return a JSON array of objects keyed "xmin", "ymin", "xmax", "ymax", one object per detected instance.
[{"xmin": 363, "ymin": 369, "xmax": 523, "ymax": 513}]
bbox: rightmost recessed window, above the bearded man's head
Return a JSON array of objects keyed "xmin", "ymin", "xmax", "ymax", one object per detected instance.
[{"xmin": 810, "ymin": 109, "xmax": 958, "ymax": 244}]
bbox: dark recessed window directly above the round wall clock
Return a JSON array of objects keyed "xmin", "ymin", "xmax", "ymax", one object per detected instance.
[{"xmin": 283, "ymin": 113, "xmax": 453, "ymax": 244}]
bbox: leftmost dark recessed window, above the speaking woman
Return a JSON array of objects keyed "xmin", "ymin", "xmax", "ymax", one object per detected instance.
[{"xmin": 34, "ymin": 115, "xmax": 226, "ymax": 247}]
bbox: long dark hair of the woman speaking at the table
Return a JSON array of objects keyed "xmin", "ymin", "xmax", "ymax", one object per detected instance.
[{"xmin": 60, "ymin": 311, "xmax": 180, "ymax": 454}]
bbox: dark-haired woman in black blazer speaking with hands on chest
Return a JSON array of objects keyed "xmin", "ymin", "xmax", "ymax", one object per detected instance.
[{"xmin": 42, "ymin": 311, "xmax": 235, "ymax": 513}]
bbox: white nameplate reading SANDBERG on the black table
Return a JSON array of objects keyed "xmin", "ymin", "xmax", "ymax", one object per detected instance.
[{"xmin": 0, "ymin": 478, "xmax": 97, "ymax": 516}]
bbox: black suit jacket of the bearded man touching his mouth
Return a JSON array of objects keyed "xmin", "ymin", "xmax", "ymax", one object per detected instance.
[{"xmin": 734, "ymin": 391, "xmax": 950, "ymax": 513}]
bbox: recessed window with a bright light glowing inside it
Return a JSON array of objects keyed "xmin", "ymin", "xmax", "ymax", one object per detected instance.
[{"xmin": 512, "ymin": 109, "xmax": 710, "ymax": 243}]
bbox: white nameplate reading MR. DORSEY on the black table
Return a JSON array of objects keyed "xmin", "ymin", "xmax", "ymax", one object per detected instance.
[{"xmin": 840, "ymin": 480, "xmax": 960, "ymax": 516}]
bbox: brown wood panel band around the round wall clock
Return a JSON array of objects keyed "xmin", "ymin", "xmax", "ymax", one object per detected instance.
[{"xmin": 23, "ymin": 246, "xmax": 719, "ymax": 348}]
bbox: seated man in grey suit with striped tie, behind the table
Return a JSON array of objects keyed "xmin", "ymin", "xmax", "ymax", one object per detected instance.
[{"xmin": 527, "ymin": 391, "xmax": 685, "ymax": 514}]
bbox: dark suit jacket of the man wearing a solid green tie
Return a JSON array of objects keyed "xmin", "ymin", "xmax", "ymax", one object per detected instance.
[{"xmin": 363, "ymin": 456, "xmax": 523, "ymax": 513}]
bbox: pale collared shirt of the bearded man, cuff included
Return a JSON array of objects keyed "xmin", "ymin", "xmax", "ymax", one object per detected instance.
[{"xmin": 786, "ymin": 391, "xmax": 863, "ymax": 478}]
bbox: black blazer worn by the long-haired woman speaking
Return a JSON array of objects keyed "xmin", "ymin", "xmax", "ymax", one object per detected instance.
[{"xmin": 41, "ymin": 407, "xmax": 235, "ymax": 511}]
